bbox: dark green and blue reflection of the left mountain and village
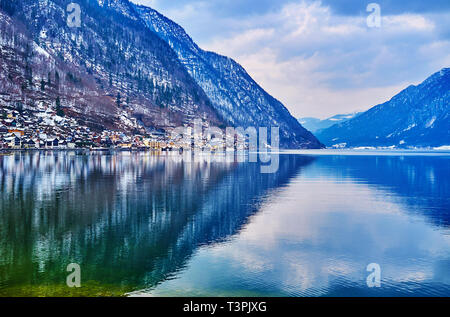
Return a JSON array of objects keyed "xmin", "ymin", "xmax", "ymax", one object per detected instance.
[{"xmin": 0, "ymin": 153, "xmax": 312, "ymax": 295}]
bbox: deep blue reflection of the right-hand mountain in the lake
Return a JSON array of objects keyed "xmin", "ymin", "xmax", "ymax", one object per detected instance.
[{"xmin": 318, "ymin": 155, "xmax": 450, "ymax": 227}]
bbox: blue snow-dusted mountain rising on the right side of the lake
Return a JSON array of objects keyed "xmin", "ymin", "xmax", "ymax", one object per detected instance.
[{"xmin": 317, "ymin": 68, "xmax": 450, "ymax": 148}]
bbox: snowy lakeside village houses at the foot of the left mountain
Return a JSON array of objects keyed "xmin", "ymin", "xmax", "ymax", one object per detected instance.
[{"xmin": 0, "ymin": 108, "xmax": 248, "ymax": 151}]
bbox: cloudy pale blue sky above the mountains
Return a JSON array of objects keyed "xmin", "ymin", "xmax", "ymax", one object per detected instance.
[{"xmin": 132, "ymin": 0, "xmax": 450, "ymax": 118}]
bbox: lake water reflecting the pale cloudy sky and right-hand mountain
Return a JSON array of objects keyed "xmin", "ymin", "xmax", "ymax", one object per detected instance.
[{"xmin": 143, "ymin": 155, "xmax": 450, "ymax": 296}]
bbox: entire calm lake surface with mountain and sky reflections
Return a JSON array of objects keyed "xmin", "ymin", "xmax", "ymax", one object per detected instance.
[{"xmin": 0, "ymin": 151, "xmax": 450, "ymax": 296}]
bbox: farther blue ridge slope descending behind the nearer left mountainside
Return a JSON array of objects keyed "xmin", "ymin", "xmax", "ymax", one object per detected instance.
[{"xmin": 132, "ymin": 6, "xmax": 322, "ymax": 148}]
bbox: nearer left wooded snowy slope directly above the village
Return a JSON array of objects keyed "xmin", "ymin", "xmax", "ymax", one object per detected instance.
[{"xmin": 0, "ymin": 0, "xmax": 223, "ymax": 131}]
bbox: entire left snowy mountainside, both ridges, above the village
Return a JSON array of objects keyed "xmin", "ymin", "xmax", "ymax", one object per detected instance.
[{"xmin": 0, "ymin": 0, "xmax": 322, "ymax": 148}]
